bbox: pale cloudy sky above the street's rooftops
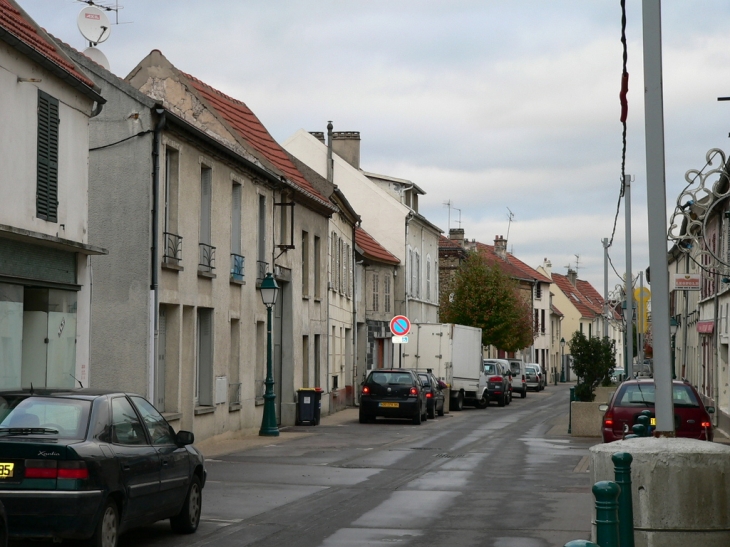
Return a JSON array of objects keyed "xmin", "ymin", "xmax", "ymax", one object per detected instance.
[{"xmin": 18, "ymin": 0, "xmax": 730, "ymax": 293}]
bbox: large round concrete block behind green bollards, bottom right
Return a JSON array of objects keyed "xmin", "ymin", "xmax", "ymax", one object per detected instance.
[{"xmin": 590, "ymin": 437, "xmax": 730, "ymax": 547}]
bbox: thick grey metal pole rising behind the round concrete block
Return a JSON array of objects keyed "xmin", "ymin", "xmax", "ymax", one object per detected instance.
[{"xmin": 642, "ymin": 0, "xmax": 674, "ymax": 437}]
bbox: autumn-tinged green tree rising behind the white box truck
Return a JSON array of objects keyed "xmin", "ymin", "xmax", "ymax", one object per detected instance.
[{"xmin": 441, "ymin": 251, "xmax": 534, "ymax": 351}]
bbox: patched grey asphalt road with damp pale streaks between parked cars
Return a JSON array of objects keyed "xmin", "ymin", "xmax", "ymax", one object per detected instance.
[{"xmin": 14, "ymin": 384, "xmax": 598, "ymax": 547}]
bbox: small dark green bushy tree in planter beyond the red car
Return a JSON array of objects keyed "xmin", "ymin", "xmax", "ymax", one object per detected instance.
[{"xmin": 569, "ymin": 332, "xmax": 616, "ymax": 402}]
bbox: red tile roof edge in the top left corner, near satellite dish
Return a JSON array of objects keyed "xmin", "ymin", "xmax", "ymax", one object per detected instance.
[{"xmin": 0, "ymin": 0, "xmax": 94, "ymax": 89}]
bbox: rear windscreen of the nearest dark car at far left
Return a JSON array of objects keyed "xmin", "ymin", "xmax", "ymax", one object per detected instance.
[{"xmin": 0, "ymin": 396, "xmax": 91, "ymax": 439}]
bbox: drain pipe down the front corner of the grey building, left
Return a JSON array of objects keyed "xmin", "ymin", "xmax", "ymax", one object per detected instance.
[{"xmin": 149, "ymin": 105, "xmax": 166, "ymax": 404}]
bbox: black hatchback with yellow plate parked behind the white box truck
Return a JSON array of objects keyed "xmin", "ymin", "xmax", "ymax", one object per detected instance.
[{"xmin": 360, "ymin": 368, "xmax": 428, "ymax": 425}]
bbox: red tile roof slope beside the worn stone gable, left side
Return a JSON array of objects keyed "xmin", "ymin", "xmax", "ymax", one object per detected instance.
[{"xmin": 181, "ymin": 71, "xmax": 328, "ymax": 201}]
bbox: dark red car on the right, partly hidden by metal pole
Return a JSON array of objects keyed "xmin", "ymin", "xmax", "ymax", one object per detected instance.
[{"xmin": 599, "ymin": 378, "xmax": 715, "ymax": 443}]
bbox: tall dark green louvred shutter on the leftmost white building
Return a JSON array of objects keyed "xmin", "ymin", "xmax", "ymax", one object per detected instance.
[{"xmin": 36, "ymin": 90, "xmax": 59, "ymax": 222}]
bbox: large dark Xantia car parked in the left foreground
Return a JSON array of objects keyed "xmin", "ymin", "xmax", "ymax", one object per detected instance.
[{"xmin": 0, "ymin": 389, "xmax": 206, "ymax": 547}]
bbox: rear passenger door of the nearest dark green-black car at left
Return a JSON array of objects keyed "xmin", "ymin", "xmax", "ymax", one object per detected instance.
[{"xmin": 111, "ymin": 396, "xmax": 160, "ymax": 520}]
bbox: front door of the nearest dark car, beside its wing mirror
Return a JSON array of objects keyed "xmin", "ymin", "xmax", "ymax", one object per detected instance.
[{"xmin": 130, "ymin": 396, "xmax": 191, "ymax": 518}]
